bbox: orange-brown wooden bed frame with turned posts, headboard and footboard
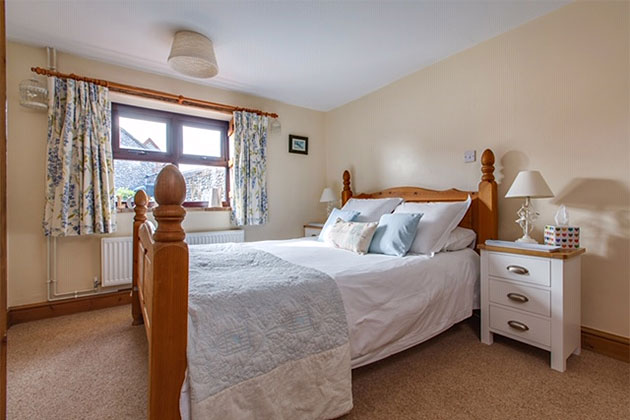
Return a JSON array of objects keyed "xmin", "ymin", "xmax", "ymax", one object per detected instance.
[{"xmin": 131, "ymin": 149, "xmax": 498, "ymax": 420}]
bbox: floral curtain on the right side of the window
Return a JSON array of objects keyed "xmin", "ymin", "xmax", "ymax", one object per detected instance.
[{"xmin": 230, "ymin": 111, "xmax": 268, "ymax": 226}]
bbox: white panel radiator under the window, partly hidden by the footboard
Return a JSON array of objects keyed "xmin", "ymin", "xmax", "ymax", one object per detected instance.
[{"xmin": 101, "ymin": 229, "xmax": 245, "ymax": 287}]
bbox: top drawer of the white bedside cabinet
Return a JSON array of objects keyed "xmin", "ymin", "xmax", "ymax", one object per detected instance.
[{"xmin": 488, "ymin": 252, "xmax": 551, "ymax": 286}]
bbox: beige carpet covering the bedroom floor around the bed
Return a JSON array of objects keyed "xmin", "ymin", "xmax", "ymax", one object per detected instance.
[{"xmin": 8, "ymin": 307, "xmax": 630, "ymax": 420}]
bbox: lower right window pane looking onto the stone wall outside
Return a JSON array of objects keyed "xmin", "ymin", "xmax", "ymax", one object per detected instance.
[{"xmin": 179, "ymin": 165, "xmax": 226, "ymax": 202}]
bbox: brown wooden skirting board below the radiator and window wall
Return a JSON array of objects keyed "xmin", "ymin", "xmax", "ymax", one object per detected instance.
[{"xmin": 7, "ymin": 289, "xmax": 131, "ymax": 327}]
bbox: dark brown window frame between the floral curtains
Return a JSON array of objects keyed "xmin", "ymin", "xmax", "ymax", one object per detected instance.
[{"xmin": 111, "ymin": 102, "xmax": 230, "ymax": 207}]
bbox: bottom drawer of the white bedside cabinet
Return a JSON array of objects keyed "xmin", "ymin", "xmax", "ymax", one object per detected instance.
[{"xmin": 490, "ymin": 305, "xmax": 551, "ymax": 347}]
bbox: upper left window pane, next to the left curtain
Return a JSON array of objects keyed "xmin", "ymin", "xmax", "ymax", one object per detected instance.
[{"xmin": 118, "ymin": 117, "xmax": 168, "ymax": 152}]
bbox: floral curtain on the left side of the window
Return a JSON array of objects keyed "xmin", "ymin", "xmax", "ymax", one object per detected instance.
[{"xmin": 43, "ymin": 78, "xmax": 116, "ymax": 236}]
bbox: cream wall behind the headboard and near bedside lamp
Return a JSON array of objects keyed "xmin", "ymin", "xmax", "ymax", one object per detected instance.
[{"xmin": 326, "ymin": 2, "xmax": 630, "ymax": 337}]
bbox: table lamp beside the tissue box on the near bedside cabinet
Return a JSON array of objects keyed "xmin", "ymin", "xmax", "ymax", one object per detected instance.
[{"xmin": 505, "ymin": 171, "xmax": 553, "ymax": 244}]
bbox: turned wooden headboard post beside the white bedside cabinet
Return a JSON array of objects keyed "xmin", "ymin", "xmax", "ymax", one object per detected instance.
[{"xmin": 475, "ymin": 149, "xmax": 499, "ymax": 244}]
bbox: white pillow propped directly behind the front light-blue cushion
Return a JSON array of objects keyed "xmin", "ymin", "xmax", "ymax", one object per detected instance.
[{"xmin": 394, "ymin": 196, "xmax": 471, "ymax": 254}]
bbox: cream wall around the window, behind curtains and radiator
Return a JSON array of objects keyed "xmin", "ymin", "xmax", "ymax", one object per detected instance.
[{"xmin": 7, "ymin": 42, "xmax": 325, "ymax": 306}]
